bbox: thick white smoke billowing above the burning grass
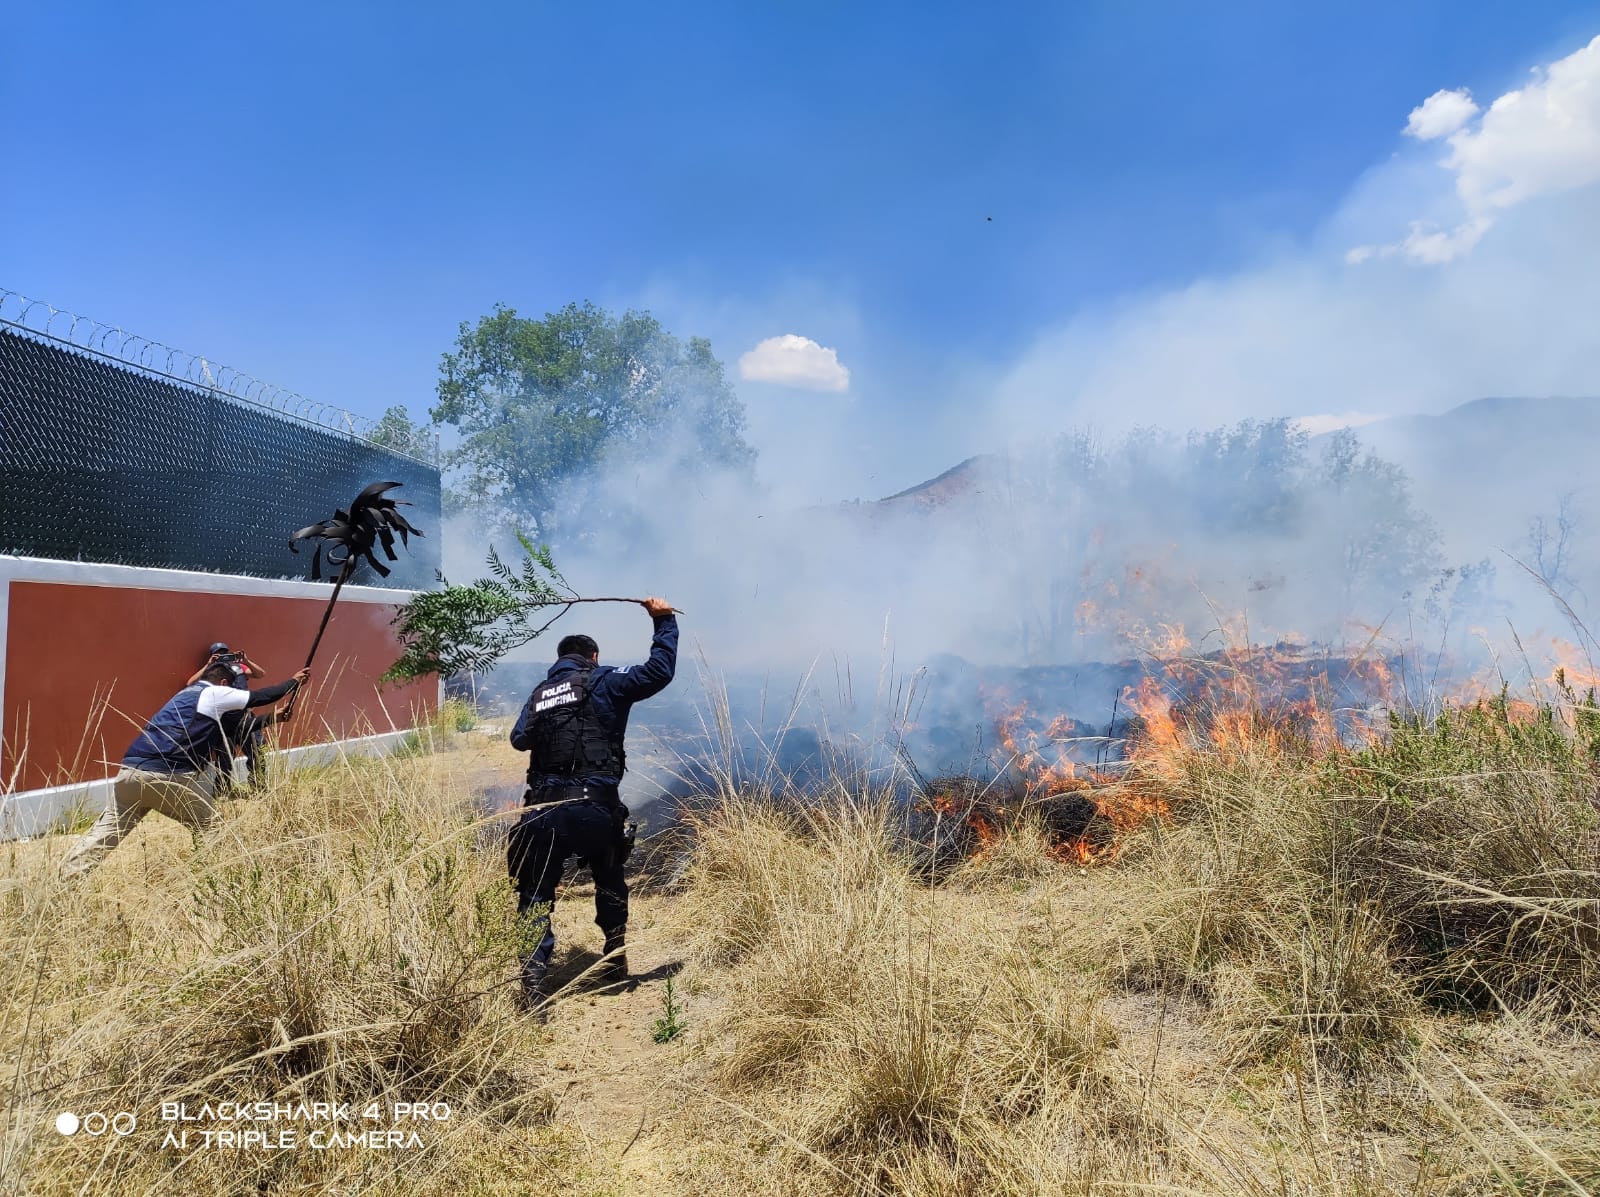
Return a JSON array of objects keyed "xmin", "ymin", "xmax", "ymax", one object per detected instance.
[{"xmin": 451, "ymin": 38, "xmax": 1600, "ymax": 784}]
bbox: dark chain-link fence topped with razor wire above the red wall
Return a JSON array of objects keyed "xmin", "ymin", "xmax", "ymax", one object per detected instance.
[{"xmin": 0, "ymin": 294, "xmax": 440, "ymax": 589}]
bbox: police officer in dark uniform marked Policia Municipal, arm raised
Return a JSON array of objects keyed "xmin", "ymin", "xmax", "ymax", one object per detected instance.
[{"xmin": 506, "ymin": 599, "xmax": 678, "ymax": 1008}]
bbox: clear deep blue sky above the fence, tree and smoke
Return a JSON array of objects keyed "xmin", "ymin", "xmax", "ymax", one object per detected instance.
[{"xmin": 0, "ymin": 2, "xmax": 1600, "ymax": 493}]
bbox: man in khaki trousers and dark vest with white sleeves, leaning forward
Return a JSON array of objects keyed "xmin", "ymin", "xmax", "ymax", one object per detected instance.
[{"xmin": 61, "ymin": 659, "xmax": 310, "ymax": 877}]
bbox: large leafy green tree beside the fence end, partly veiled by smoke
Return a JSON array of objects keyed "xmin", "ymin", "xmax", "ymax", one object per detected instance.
[{"xmin": 432, "ymin": 302, "xmax": 755, "ymax": 542}]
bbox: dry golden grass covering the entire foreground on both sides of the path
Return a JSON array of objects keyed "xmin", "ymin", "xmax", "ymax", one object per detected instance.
[{"xmin": 0, "ymin": 697, "xmax": 1600, "ymax": 1197}]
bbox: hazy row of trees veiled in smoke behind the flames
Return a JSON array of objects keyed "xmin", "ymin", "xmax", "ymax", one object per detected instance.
[{"xmin": 987, "ymin": 419, "xmax": 1465, "ymax": 659}]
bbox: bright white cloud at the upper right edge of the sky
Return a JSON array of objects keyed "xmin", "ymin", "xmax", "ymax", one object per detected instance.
[{"xmin": 1346, "ymin": 37, "xmax": 1600, "ymax": 266}]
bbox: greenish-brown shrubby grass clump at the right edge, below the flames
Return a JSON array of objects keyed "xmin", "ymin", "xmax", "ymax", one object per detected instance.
[{"xmin": 1317, "ymin": 690, "xmax": 1600, "ymax": 1027}]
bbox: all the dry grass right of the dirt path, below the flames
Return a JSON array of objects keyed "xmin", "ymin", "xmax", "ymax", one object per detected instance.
[{"xmin": 656, "ymin": 688, "xmax": 1600, "ymax": 1195}]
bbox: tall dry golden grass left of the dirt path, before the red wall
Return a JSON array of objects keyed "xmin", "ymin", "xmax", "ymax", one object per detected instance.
[{"xmin": 0, "ymin": 757, "xmax": 547, "ymax": 1194}]
